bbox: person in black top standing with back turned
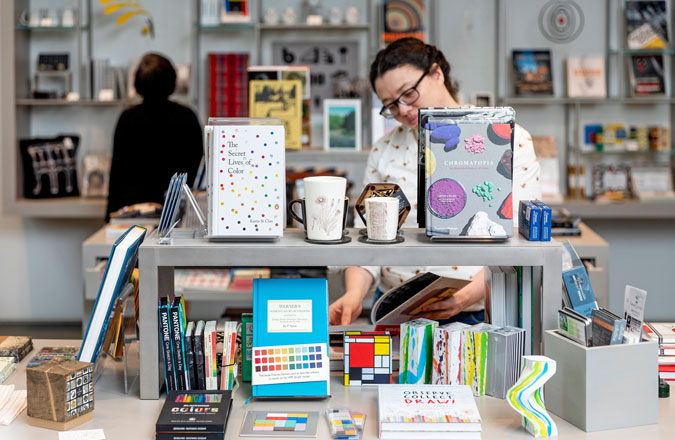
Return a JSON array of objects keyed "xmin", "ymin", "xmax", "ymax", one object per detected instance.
[{"xmin": 106, "ymin": 53, "xmax": 203, "ymax": 221}]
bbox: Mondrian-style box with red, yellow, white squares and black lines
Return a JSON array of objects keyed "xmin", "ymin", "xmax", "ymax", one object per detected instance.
[{"xmin": 344, "ymin": 331, "xmax": 392, "ymax": 386}]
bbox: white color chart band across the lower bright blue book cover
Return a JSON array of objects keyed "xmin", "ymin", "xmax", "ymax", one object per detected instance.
[{"xmin": 253, "ymin": 343, "xmax": 330, "ymax": 385}]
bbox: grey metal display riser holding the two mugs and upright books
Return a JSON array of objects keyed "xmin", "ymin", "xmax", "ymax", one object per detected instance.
[{"xmin": 139, "ymin": 229, "xmax": 562, "ymax": 399}]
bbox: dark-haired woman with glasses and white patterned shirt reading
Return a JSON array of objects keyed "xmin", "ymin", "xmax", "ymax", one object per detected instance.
[{"xmin": 329, "ymin": 38, "xmax": 541, "ymax": 325}]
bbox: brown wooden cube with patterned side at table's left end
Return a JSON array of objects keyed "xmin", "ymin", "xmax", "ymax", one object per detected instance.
[{"xmin": 26, "ymin": 359, "xmax": 94, "ymax": 429}]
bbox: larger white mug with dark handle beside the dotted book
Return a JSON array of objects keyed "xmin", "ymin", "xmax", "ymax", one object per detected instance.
[{"xmin": 288, "ymin": 176, "xmax": 347, "ymax": 241}]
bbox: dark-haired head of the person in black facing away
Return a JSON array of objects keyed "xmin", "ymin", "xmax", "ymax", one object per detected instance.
[{"xmin": 134, "ymin": 53, "xmax": 176, "ymax": 99}]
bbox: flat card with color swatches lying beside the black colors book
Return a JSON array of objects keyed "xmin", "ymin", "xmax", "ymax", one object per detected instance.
[{"xmin": 239, "ymin": 411, "xmax": 319, "ymax": 438}]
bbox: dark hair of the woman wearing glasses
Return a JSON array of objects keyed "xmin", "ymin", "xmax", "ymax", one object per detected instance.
[{"xmin": 370, "ymin": 37, "xmax": 459, "ymax": 100}]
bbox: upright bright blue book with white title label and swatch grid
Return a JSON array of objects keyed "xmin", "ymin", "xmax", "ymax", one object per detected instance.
[{"xmin": 252, "ymin": 278, "xmax": 330, "ymax": 398}]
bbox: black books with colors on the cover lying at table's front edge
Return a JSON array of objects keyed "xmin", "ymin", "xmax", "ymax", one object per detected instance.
[{"xmin": 155, "ymin": 391, "xmax": 232, "ymax": 440}]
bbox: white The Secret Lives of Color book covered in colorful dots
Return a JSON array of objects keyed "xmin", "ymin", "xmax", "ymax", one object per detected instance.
[{"xmin": 209, "ymin": 118, "xmax": 286, "ymax": 239}]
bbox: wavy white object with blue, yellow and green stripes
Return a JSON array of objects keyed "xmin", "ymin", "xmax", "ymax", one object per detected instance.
[{"xmin": 506, "ymin": 356, "xmax": 558, "ymax": 437}]
